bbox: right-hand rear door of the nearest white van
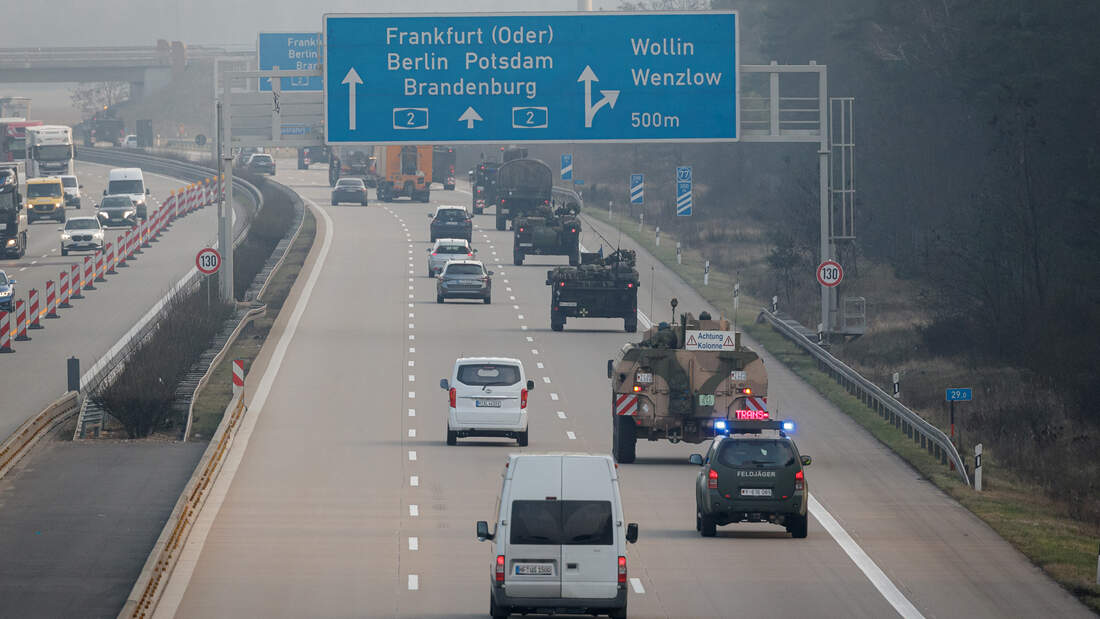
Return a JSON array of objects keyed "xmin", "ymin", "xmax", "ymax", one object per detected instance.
[{"xmin": 561, "ymin": 456, "xmax": 619, "ymax": 598}]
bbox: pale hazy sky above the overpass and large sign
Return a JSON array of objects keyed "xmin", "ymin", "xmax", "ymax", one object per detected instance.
[{"xmin": 0, "ymin": 0, "xmax": 619, "ymax": 47}]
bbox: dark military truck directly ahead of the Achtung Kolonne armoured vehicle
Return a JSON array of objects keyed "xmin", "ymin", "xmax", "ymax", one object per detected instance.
[{"xmin": 547, "ymin": 250, "xmax": 639, "ymax": 333}]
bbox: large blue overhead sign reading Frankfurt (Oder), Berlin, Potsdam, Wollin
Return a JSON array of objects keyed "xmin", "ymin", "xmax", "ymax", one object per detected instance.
[{"xmin": 322, "ymin": 11, "xmax": 739, "ymax": 144}]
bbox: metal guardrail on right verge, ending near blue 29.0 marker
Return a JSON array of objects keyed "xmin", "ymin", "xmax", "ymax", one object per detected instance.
[{"xmin": 760, "ymin": 309, "xmax": 971, "ymax": 486}]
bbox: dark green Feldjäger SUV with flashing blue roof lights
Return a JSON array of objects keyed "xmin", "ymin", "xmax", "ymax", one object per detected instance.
[{"xmin": 690, "ymin": 420, "xmax": 811, "ymax": 538}]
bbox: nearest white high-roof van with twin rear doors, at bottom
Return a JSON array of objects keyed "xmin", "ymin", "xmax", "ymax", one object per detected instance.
[{"xmin": 476, "ymin": 454, "xmax": 638, "ymax": 619}]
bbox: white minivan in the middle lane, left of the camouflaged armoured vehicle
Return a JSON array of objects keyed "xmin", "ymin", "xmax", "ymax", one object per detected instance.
[{"xmin": 439, "ymin": 357, "xmax": 535, "ymax": 447}]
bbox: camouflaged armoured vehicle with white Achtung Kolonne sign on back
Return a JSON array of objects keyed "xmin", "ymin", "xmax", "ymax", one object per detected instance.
[{"xmin": 607, "ymin": 305, "xmax": 768, "ymax": 463}]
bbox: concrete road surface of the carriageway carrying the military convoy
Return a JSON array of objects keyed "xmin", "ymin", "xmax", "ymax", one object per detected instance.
[{"xmin": 157, "ymin": 167, "xmax": 1090, "ymax": 618}]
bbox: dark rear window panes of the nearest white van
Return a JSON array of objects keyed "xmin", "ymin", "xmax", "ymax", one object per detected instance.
[{"xmin": 510, "ymin": 500, "xmax": 615, "ymax": 545}]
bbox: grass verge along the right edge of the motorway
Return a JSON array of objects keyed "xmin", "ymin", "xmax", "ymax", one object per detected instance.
[{"xmin": 584, "ymin": 209, "xmax": 1100, "ymax": 614}]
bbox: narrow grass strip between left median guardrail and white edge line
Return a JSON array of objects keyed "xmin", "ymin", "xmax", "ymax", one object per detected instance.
[{"xmin": 189, "ymin": 209, "xmax": 317, "ymax": 441}]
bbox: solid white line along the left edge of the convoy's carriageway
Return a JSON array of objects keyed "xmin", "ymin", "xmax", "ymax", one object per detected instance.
[{"xmin": 154, "ymin": 196, "xmax": 336, "ymax": 618}]
